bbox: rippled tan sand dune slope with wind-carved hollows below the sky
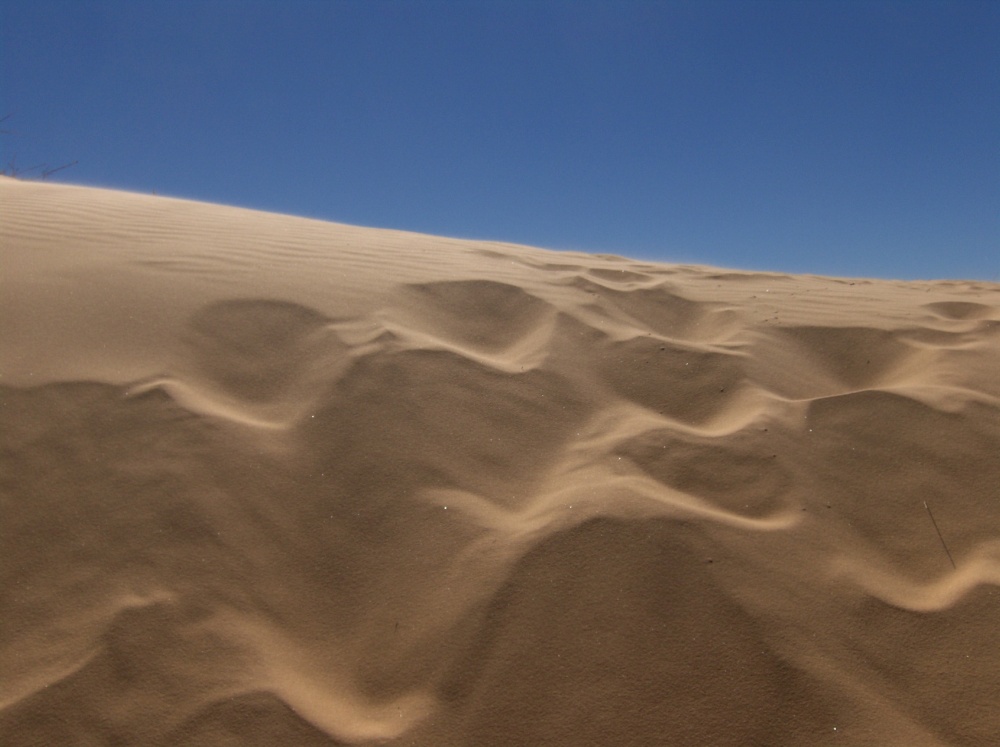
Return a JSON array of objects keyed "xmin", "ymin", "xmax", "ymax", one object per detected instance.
[{"xmin": 0, "ymin": 179, "xmax": 1000, "ymax": 747}]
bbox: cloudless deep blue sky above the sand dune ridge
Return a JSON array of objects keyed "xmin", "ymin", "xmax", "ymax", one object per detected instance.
[{"xmin": 0, "ymin": 0, "xmax": 1000, "ymax": 280}]
